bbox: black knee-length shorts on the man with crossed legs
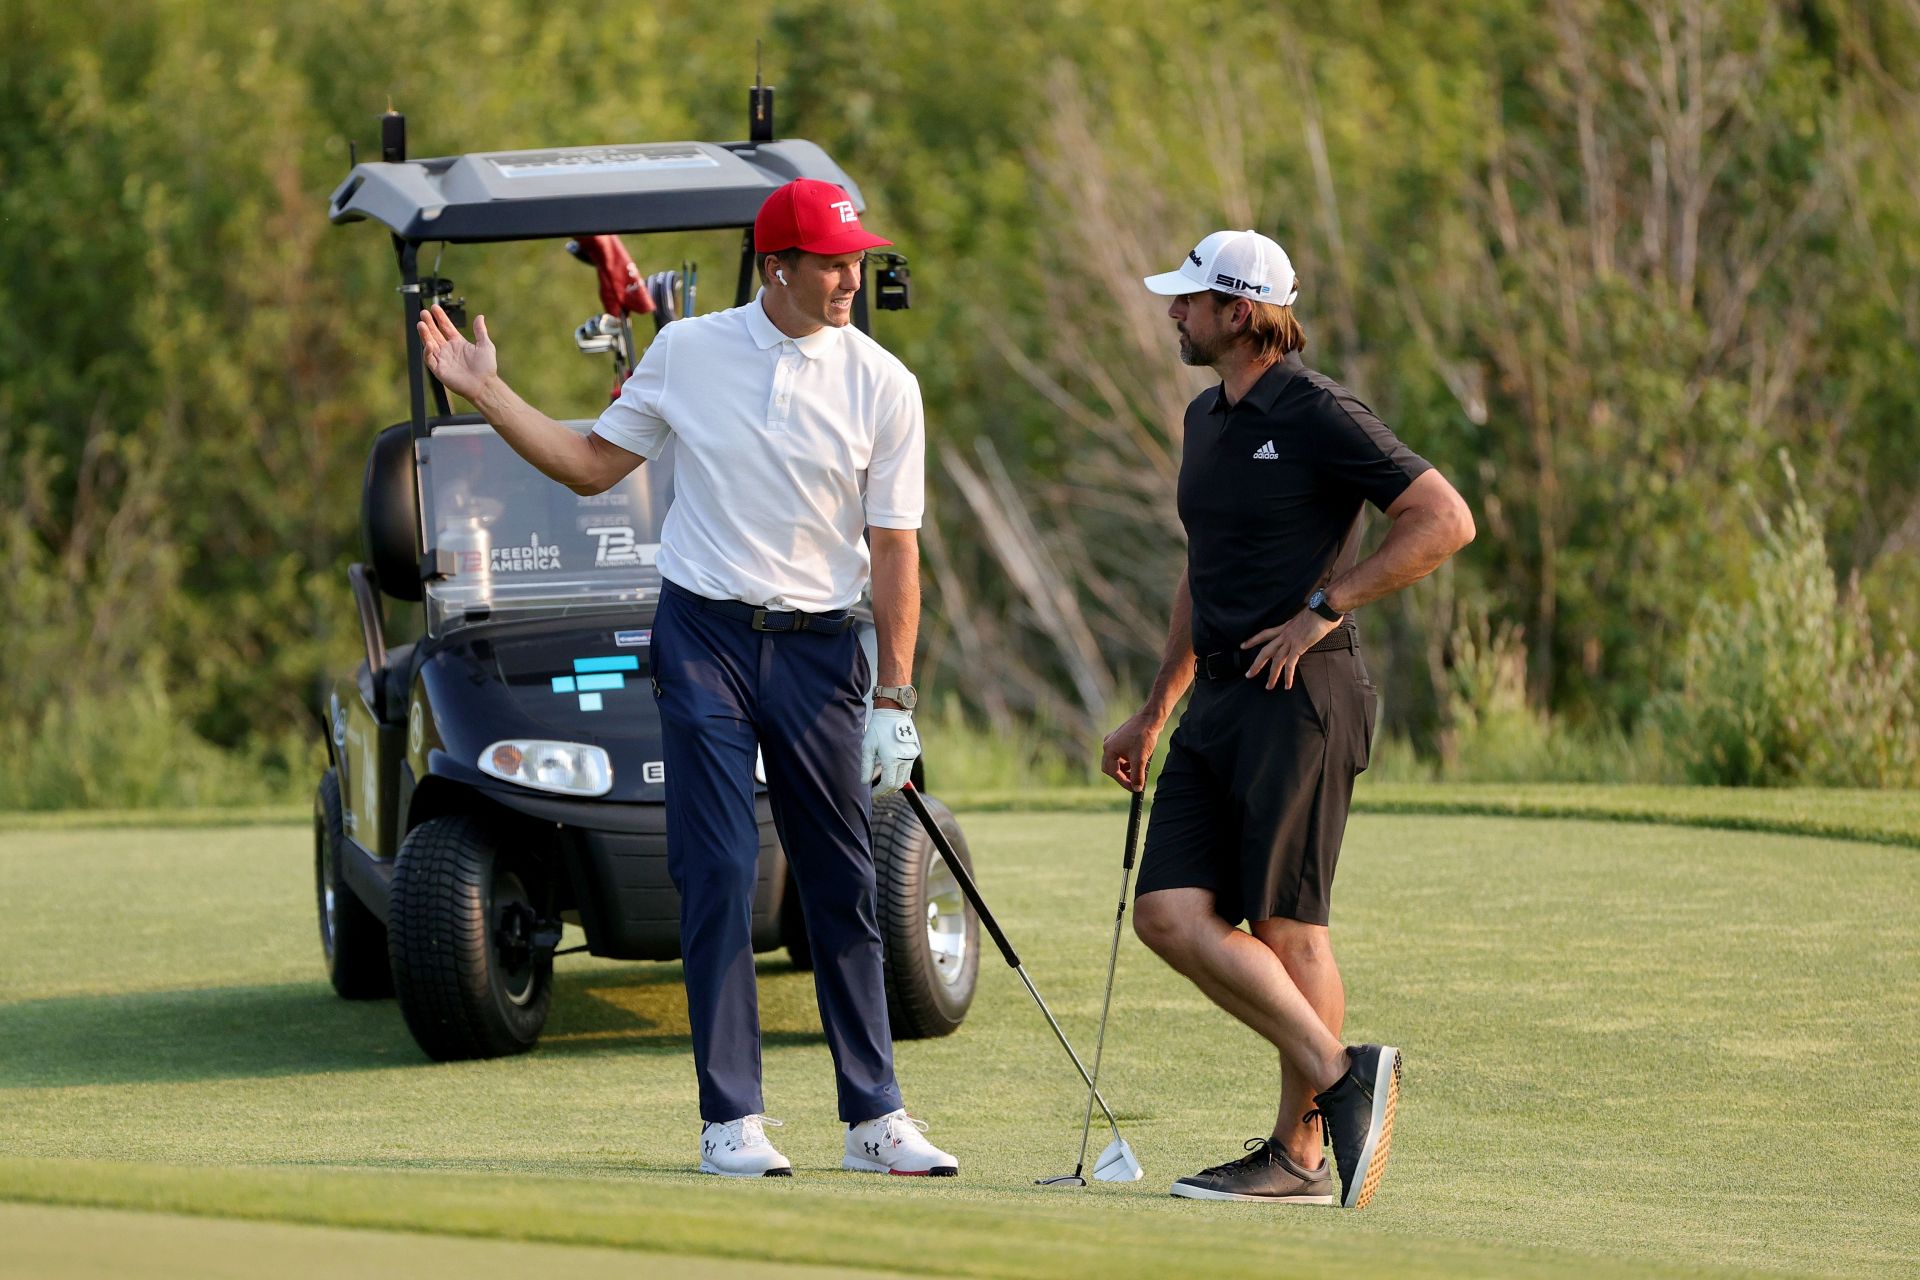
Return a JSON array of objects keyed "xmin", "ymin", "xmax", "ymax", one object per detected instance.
[{"xmin": 1137, "ymin": 649, "xmax": 1379, "ymax": 925}]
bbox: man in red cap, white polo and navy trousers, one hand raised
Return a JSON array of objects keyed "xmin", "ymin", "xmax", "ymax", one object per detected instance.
[{"xmin": 420, "ymin": 178, "xmax": 960, "ymax": 1176}]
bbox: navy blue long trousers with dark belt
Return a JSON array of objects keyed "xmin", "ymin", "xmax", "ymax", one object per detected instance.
[{"xmin": 653, "ymin": 585, "xmax": 900, "ymax": 1125}]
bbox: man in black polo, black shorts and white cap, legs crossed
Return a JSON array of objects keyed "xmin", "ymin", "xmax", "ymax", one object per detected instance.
[{"xmin": 1100, "ymin": 230, "xmax": 1473, "ymax": 1209}]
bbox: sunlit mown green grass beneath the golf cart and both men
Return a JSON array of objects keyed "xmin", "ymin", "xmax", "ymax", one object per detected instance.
[{"xmin": 0, "ymin": 809, "xmax": 1920, "ymax": 1276}]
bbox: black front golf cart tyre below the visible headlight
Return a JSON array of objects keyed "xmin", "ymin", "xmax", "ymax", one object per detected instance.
[{"xmin": 388, "ymin": 814, "xmax": 553, "ymax": 1061}]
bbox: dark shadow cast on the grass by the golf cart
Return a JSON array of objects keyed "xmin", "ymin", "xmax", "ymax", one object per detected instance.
[{"xmin": 0, "ymin": 960, "xmax": 824, "ymax": 1088}]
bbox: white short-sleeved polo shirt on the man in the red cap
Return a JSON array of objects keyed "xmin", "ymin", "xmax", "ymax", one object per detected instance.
[{"xmin": 593, "ymin": 290, "xmax": 925, "ymax": 612}]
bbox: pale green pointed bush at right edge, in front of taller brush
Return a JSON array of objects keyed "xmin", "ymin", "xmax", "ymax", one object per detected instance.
[{"xmin": 1665, "ymin": 459, "xmax": 1920, "ymax": 787}]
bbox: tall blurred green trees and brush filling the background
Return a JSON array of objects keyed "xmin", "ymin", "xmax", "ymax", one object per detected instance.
[{"xmin": 0, "ymin": 0, "xmax": 1920, "ymax": 802}]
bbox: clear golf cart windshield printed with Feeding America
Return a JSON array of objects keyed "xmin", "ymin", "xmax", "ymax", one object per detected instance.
[{"xmin": 424, "ymin": 422, "xmax": 674, "ymax": 635}]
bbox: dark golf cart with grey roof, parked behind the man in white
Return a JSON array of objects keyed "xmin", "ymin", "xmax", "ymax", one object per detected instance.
[{"xmin": 313, "ymin": 97, "xmax": 979, "ymax": 1059}]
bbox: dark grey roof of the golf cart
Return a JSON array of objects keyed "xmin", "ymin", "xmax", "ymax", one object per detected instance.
[{"xmin": 328, "ymin": 138, "xmax": 866, "ymax": 244}]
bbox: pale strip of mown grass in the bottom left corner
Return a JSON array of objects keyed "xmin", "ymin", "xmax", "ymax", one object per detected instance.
[{"xmin": 0, "ymin": 1203, "xmax": 883, "ymax": 1280}]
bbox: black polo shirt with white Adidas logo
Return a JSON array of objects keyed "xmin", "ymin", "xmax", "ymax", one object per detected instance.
[{"xmin": 1179, "ymin": 355, "xmax": 1432, "ymax": 654}]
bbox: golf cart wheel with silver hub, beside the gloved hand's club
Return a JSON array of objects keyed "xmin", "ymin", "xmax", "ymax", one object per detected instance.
[{"xmin": 874, "ymin": 794, "xmax": 979, "ymax": 1040}]
